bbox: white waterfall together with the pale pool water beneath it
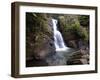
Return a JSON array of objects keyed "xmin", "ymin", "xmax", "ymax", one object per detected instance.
[{"xmin": 52, "ymin": 19, "xmax": 76, "ymax": 64}]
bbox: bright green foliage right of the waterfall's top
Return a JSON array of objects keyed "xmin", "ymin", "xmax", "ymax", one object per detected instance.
[{"xmin": 58, "ymin": 15, "xmax": 88, "ymax": 41}]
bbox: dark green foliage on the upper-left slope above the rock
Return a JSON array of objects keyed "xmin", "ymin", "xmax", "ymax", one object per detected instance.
[{"xmin": 26, "ymin": 13, "xmax": 53, "ymax": 36}]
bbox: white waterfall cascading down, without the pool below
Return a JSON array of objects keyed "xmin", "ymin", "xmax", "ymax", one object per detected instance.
[{"xmin": 52, "ymin": 19, "xmax": 68, "ymax": 51}]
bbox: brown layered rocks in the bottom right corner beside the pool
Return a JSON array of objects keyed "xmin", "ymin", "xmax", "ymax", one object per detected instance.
[{"xmin": 67, "ymin": 49, "xmax": 89, "ymax": 65}]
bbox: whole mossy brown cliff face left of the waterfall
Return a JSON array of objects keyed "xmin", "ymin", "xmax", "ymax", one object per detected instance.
[{"xmin": 26, "ymin": 13, "xmax": 55, "ymax": 59}]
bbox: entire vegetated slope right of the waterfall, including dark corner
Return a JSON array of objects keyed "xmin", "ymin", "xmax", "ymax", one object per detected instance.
[{"xmin": 58, "ymin": 15, "xmax": 89, "ymax": 48}]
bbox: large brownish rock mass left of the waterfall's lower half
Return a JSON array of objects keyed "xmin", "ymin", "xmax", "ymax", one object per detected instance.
[{"xmin": 28, "ymin": 33, "xmax": 55, "ymax": 59}]
